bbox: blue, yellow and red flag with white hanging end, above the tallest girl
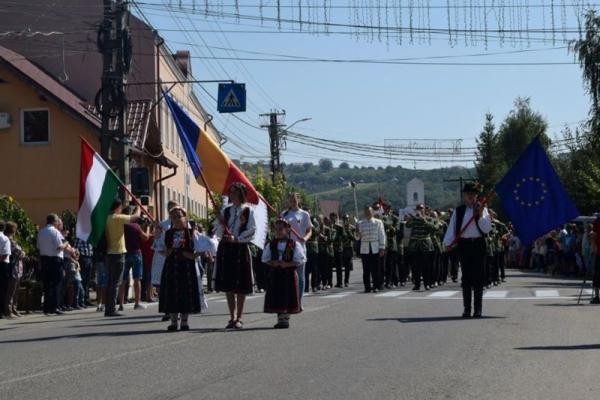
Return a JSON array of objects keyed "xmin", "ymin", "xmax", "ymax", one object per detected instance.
[{"xmin": 164, "ymin": 94, "xmax": 268, "ymax": 249}]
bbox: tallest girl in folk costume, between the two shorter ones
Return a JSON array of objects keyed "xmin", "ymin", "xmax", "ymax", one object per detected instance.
[{"xmin": 214, "ymin": 182, "xmax": 256, "ymax": 329}]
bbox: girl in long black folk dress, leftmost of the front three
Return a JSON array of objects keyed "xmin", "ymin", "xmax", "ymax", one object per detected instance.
[{"xmin": 158, "ymin": 207, "xmax": 201, "ymax": 331}]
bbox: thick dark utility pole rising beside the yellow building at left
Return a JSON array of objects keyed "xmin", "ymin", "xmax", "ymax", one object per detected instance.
[{"xmin": 96, "ymin": 0, "xmax": 132, "ymax": 198}]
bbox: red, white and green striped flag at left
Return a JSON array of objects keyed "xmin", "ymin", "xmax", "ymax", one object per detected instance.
[{"xmin": 77, "ymin": 139, "xmax": 120, "ymax": 245}]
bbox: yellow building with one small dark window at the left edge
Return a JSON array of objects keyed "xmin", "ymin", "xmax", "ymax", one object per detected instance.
[{"xmin": 0, "ymin": 47, "xmax": 100, "ymax": 225}]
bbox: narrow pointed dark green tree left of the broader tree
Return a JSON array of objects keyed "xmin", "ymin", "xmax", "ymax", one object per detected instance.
[{"xmin": 475, "ymin": 113, "xmax": 504, "ymax": 190}]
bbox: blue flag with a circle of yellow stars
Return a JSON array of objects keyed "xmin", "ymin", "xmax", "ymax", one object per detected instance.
[{"xmin": 496, "ymin": 137, "xmax": 579, "ymax": 244}]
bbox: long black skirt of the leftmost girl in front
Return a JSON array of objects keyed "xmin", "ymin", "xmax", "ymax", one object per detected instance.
[{"xmin": 158, "ymin": 254, "xmax": 201, "ymax": 314}]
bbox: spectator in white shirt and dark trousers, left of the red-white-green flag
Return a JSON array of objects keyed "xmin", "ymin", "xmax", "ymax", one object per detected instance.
[{"xmin": 37, "ymin": 214, "xmax": 72, "ymax": 314}]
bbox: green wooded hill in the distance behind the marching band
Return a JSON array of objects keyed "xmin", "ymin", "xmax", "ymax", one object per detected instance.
[{"xmin": 244, "ymin": 163, "xmax": 475, "ymax": 213}]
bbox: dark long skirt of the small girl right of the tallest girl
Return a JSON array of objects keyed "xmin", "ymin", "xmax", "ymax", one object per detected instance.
[{"xmin": 264, "ymin": 268, "xmax": 301, "ymax": 314}]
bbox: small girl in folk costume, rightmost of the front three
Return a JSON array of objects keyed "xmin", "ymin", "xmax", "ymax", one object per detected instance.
[{"xmin": 262, "ymin": 219, "xmax": 306, "ymax": 329}]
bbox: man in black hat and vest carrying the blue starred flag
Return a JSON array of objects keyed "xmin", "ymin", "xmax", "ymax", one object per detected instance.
[{"xmin": 444, "ymin": 182, "xmax": 492, "ymax": 318}]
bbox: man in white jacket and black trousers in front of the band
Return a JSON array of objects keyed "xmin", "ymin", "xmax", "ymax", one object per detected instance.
[{"xmin": 358, "ymin": 206, "xmax": 386, "ymax": 293}]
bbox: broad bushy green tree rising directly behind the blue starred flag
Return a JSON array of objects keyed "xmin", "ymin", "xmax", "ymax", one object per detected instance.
[{"xmin": 498, "ymin": 97, "xmax": 550, "ymax": 168}]
